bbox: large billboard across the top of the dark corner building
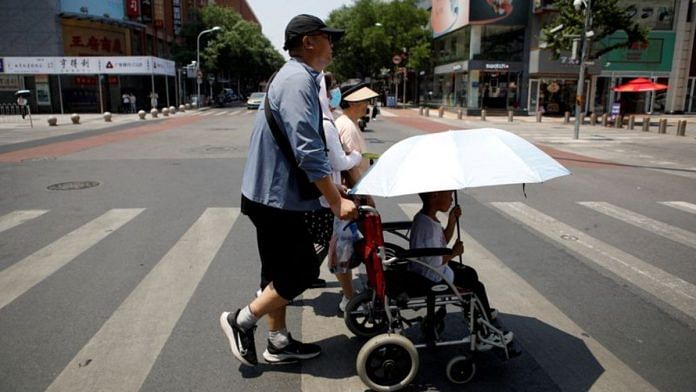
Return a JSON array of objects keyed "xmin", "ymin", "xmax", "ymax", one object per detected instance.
[{"xmin": 430, "ymin": 0, "xmax": 530, "ymax": 38}]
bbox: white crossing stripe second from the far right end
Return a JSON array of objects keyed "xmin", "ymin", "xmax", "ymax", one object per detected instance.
[{"xmin": 578, "ymin": 201, "xmax": 696, "ymax": 248}]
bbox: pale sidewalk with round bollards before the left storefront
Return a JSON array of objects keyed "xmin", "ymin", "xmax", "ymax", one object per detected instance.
[{"xmin": 0, "ymin": 108, "xmax": 207, "ymax": 146}]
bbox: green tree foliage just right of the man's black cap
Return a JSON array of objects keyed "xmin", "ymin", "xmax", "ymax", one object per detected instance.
[{"xmin": 326, "ymin": 0, "xmax": 432, "ymax": 80}]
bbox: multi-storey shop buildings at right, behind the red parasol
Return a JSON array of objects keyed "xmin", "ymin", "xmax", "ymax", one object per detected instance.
[{"xmin": 420, "ymin": 0, "xmax": 696, "ymax": 115}]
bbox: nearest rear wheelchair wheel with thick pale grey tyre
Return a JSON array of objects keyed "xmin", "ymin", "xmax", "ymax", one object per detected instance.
[{"xmin": 356, "ymin": 334, "xmax": 419, "ymax": 392}]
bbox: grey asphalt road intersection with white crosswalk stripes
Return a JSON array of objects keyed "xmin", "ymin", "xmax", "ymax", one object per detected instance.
[{"xmin": 0, "ymin": 108, "xmax": 696, "ymax": 391}]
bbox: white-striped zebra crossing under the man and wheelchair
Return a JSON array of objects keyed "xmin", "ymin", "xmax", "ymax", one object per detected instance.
[{"xmin": 0, "ymin": 201, "xmax": 696, "ymax": 391}]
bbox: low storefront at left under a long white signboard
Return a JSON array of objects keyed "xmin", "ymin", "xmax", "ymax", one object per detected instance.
[{"xmin": 0, "ymin": 56, "xmax": 177, "ymax": 113}]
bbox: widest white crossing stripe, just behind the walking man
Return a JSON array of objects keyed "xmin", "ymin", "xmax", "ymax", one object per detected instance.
[{"xmin": 47, "ymin": 208, "xmax": 239, "ymax": 392}]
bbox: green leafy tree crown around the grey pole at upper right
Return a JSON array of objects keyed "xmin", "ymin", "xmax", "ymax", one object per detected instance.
[{"xmin": 542, "ymin": 0, "xmax": 648, "ymax": 60}]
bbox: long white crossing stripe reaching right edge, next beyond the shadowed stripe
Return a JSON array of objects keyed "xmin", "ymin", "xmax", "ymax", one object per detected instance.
[{"xmin": 491, "ymin": 202, "xmax": 696, "ymax": 320}]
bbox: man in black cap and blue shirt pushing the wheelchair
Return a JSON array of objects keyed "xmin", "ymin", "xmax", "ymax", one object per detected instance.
[{"xmin": 220, "ymin": 15, "xmax": 357, "ymax": 366}]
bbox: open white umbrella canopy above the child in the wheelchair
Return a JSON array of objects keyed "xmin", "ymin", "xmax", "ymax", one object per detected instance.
[{"xmin": 351, "ymin": 128, "xmax": 570, "ymax": 197}]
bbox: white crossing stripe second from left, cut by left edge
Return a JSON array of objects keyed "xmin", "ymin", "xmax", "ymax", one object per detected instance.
[{"xmin": 0, "ymin": 208, "xmax": 144, "ymax": 309}]
